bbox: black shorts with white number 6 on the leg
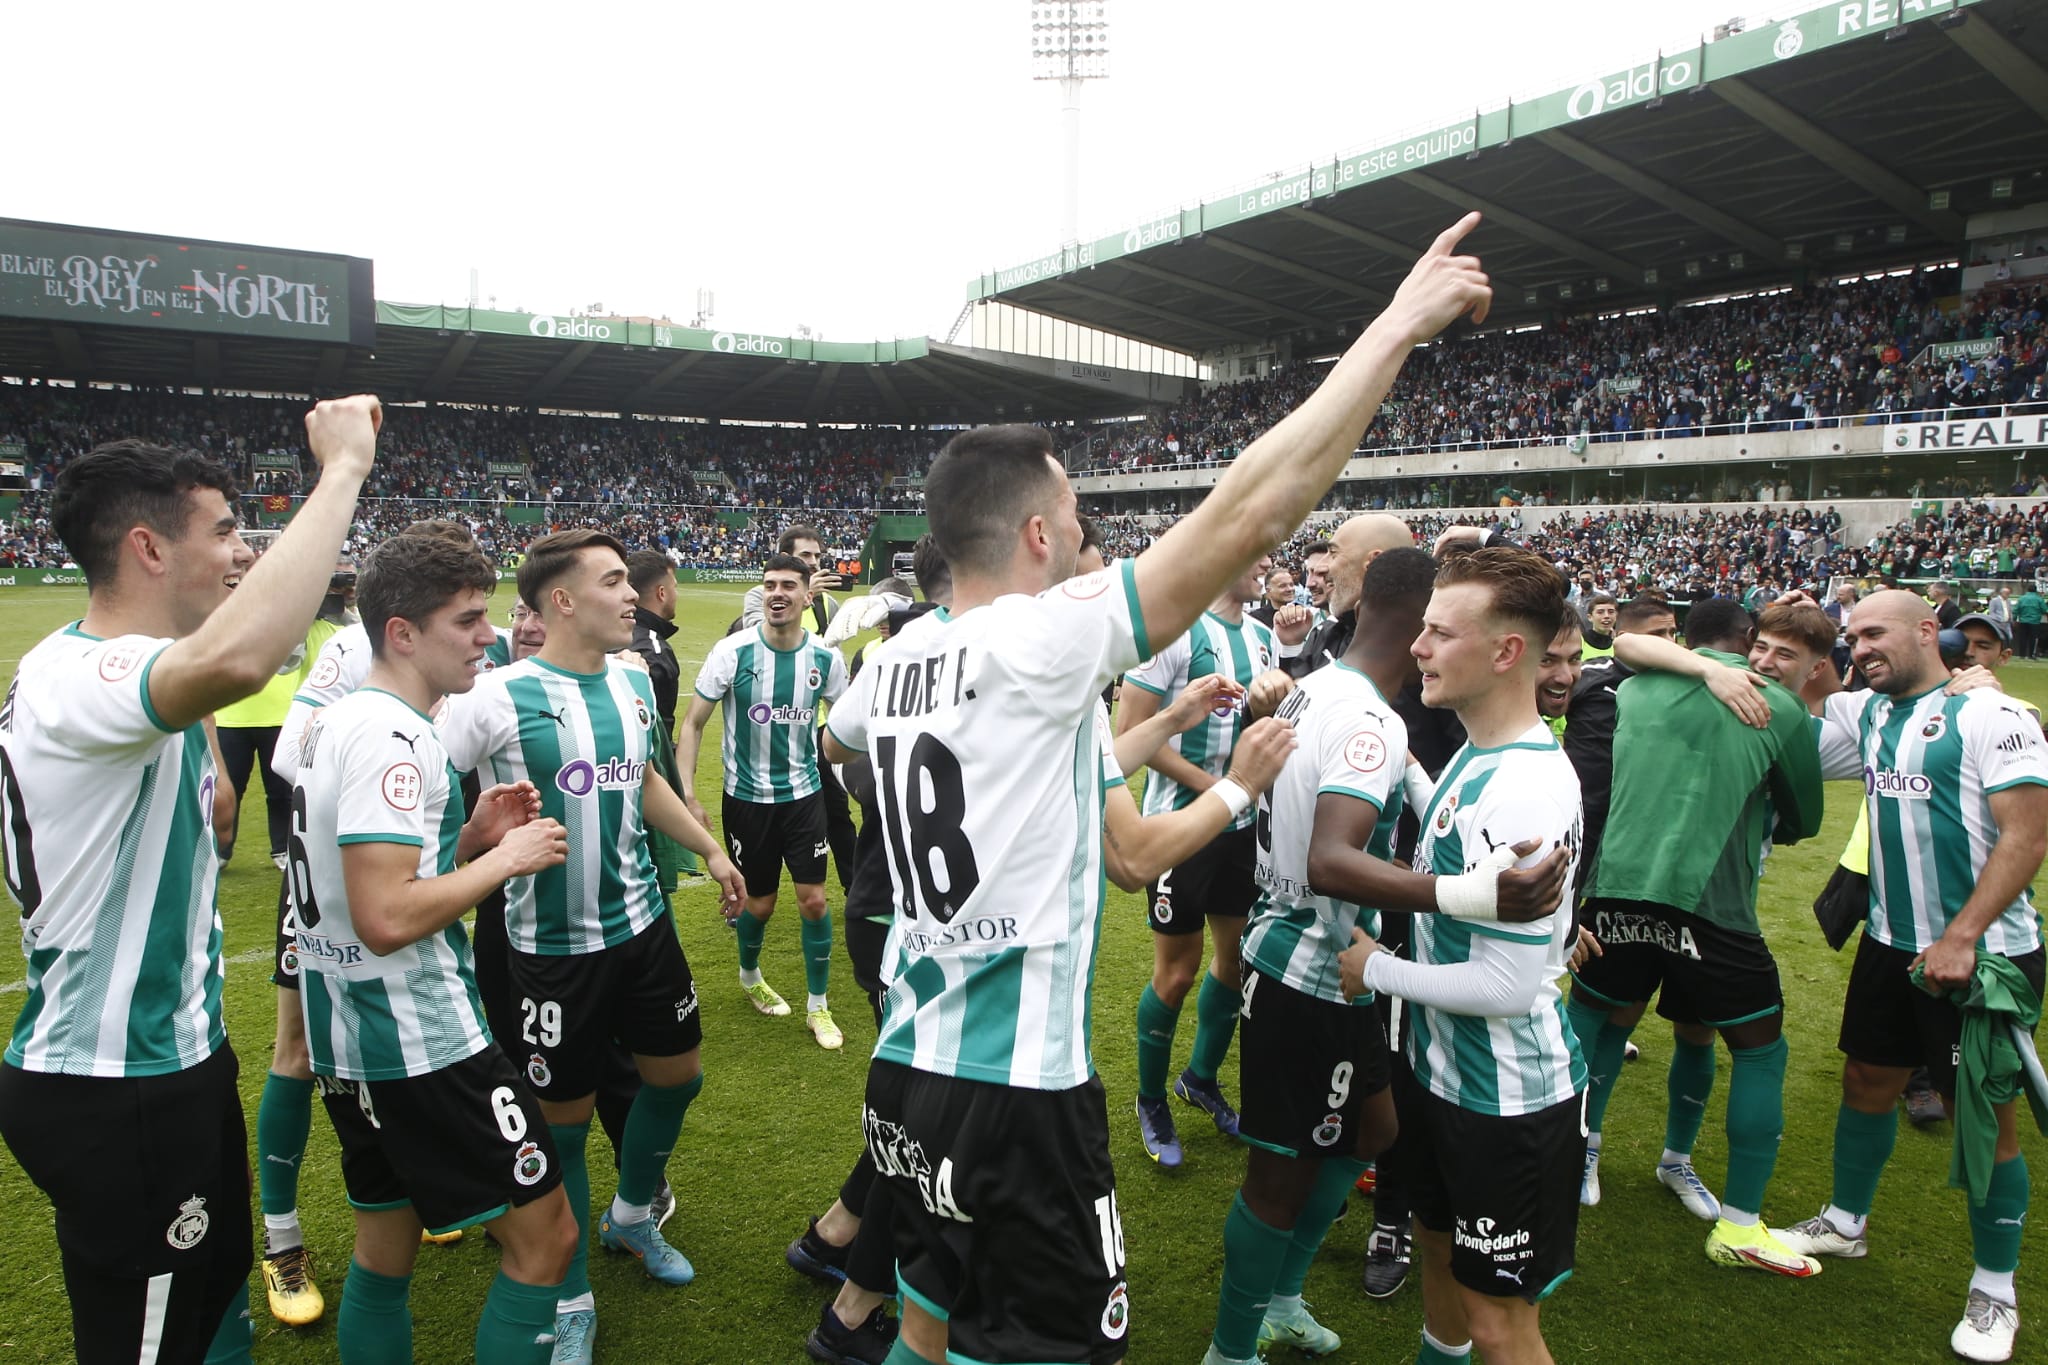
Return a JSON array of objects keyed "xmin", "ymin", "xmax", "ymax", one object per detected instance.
[{"xmin": 317, "ymin": 1044, "xmax": 561, "ymax": 1232}]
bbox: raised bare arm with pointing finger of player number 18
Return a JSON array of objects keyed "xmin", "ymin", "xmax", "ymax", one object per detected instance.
[{"xmin": 1137, "ymin": 213, "xmax": 1493, "ymax": 654}]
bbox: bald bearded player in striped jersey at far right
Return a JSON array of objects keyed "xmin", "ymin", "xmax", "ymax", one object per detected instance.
[{"xmin": 1782, "ymin": 591, "xmax": 2048, "ymax": 1361}]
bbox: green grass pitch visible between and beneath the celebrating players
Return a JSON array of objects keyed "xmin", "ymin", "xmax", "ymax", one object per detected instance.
[{"xmin": 0, "ymin": 585, "xmax": 2048, "ymax": 1365}]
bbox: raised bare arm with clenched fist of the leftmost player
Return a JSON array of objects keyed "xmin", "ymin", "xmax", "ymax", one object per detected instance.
[{"xmin": 147, "ymin": 395, "xmax": 383, "ymax": 731}]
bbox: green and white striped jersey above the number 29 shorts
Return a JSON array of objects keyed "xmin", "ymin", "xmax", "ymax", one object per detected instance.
[{"xmin": 440, "ymin": 657, "xmax": 668, "ymax": 958}]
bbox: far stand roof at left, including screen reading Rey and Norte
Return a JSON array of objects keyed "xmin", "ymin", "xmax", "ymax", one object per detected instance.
[{"xmin": 0, "ymin": 219, "xmax": 1192, "ymax": 426}]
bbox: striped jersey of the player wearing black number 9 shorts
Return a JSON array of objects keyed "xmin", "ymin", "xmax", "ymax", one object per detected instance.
[{"xmin": 1243, "ymin": 659, "xmax": 1407, "ymax": 1005}]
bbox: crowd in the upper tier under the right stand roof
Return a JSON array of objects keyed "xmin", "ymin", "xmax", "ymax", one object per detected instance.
[{"xmin": 1085, "ymin": 268, "xmax": 2048, "ymax": 469}]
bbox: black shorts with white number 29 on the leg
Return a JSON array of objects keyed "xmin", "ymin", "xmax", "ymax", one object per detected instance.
[{"xmin": 506, "ymin": 915, "xmax": 705, "ymax": 1101}]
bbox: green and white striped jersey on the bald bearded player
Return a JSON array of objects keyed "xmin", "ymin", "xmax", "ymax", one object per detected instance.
[{"xmin": 1817, "ymin": 679, "xmax": 2048, "ymax": 958}]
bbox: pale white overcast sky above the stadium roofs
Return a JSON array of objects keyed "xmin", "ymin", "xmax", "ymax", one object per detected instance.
[{"xmin": 0, "ymin": 0, "xmax": 1777, "ymax": 351}]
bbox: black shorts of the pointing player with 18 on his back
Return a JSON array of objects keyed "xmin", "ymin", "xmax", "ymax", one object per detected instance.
[{"xmin": 862, "ymin": 1062, "xmax": 1130, "ymax": 1365}]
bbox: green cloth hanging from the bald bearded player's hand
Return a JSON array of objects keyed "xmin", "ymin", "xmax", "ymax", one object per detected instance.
[{"xmin": 1913, "ymin": 952, "xmax": 2048, "ymax": 1203}]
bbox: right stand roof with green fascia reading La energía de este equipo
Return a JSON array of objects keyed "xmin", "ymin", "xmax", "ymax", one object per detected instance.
[{"xmin": 969, "ymin": 0, "xmax": 2048, "ymax": 352}]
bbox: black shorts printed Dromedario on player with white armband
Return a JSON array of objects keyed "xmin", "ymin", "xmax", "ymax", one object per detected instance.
[{"xmin": 1397, "ymin": 1068, "xmax": 1585, "ymax": 1304}]
